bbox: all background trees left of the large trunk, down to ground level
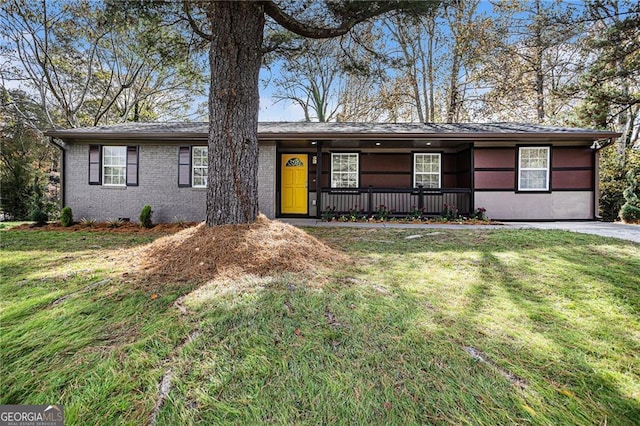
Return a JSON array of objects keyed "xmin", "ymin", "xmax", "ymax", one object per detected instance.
[{"xmin": 0, "ymin": 0, "xmax": 207, "ymax": 219}]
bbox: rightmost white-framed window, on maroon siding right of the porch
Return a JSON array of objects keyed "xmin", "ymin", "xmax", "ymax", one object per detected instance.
[{"xmin": 518, "ymin": 146, "xmax": 551, "ymax": 191}]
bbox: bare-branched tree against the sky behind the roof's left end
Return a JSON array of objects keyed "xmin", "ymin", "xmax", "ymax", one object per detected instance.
[{"xmin": 0, "ymin": 0, "xmax": 204, "ymax": 127}]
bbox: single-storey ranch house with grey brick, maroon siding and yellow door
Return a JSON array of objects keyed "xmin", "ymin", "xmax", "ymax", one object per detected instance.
[{"xmin": 46, "ymin": 122, "xmax": 619, "ymax": 222}]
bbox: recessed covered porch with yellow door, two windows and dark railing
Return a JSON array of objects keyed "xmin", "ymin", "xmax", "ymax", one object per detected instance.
[{"xmin": 276, "ymin": 136, "xmax": 473, "ymax": 219}]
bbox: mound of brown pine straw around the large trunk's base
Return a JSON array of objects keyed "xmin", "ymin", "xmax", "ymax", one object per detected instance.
[{"xmin": 121, "ymin": 215, "xmax": 349, "ymax": 281}]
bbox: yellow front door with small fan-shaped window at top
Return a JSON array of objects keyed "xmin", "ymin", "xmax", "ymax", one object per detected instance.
[{"xmin": 280, "ymin": 154, "xmax": 308, "ymax": 214}]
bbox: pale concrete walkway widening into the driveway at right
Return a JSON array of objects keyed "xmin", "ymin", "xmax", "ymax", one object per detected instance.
[{"xmin": 280, "ymin": 219, "xmax": 640, "ymax": 243}]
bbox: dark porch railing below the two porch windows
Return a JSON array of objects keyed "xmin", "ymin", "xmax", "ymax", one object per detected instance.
[{"xmin": 318, "ymin": 186, "xmax": 471, "ymax": 216}]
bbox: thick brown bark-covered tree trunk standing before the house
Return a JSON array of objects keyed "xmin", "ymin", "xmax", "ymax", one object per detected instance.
[{"xmin": 207, "ymin": 2, "xmax": 265, "ymax": 226}]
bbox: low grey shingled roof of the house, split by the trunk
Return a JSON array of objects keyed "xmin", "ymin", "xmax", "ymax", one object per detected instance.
[{"xmin": 45, "ymin": 122, "xmax": 620, "ymax": 141}]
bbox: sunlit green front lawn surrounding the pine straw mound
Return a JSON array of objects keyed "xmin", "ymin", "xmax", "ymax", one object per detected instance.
[{"xmin": 0, "ymin": 227, "xmax": 640, "ymax": 425}]
